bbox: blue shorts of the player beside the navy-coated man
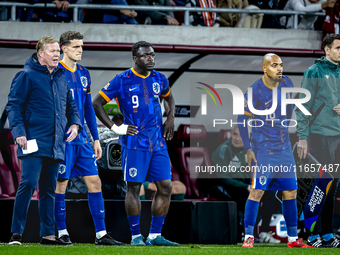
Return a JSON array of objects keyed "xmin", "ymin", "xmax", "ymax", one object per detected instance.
[{"xmin": 58, "ymin": 143, "xmax": 98, "ymax": 179}]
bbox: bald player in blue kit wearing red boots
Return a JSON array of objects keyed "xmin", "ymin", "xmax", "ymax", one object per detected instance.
[{"xmin": 238, "ymin": 53, "xmax": 314, "ymax": 248}]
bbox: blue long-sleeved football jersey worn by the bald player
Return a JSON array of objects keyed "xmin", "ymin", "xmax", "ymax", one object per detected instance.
[{"xmin": 238, "ymin": 76, "xmax": 293, "ymax": 154}]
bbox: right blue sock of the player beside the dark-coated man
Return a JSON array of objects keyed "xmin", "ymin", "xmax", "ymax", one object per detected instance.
[{"xmin": 88, "ymin": 192, "xmax": 106, "ymax": 233}]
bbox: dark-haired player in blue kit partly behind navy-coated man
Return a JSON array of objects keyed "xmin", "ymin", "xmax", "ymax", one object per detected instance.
[{"xmin": 55, "ymin": 31, "xmax": 124, "ymax": 245}]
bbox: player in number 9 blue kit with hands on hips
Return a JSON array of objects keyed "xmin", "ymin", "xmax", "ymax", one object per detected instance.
[{"xmin": 93, "ymin": 41, "xmax": 179, "ymax": 246}]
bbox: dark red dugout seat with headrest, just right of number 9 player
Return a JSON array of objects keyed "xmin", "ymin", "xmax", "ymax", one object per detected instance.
[{"xmin": 177, "ymin": 125, "xmax": 211, "ymax": 200}]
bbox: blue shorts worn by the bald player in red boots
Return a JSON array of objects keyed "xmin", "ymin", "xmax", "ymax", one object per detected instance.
[{"xmin": 250, "ymin": 149, "xmax": 297, "ymax": 190}]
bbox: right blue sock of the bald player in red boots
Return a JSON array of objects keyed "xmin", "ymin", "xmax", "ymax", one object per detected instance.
[{"xmin": 282, "ymin": 199, "xmax": 298, "ymax": 237}]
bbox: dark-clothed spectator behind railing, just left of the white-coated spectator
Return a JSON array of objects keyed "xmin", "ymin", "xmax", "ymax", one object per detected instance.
[{"xmin": 249, "ymin": 0, "xmax": 286, "ymax": 28}]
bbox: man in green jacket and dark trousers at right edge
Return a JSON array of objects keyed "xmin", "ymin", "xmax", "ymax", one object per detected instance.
[{"xmin": 296, "ymin": 34, "xmax": 340, "ymax": 248}]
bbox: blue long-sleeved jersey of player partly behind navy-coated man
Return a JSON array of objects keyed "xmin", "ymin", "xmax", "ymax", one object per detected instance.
[{"xmin": 59, "ymin": 61, "xmax": 99, "ymax": 145}]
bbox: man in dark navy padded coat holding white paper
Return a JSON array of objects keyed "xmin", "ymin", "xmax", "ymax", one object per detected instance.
[{"xmin": 6, "ymin": 36, "xmax": 82, "ymax": 244}]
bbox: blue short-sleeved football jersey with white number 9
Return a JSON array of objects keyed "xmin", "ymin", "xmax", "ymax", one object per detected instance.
[{"xmin": 99, "ymin": 68, "xmax": 170, "ymax": 151}]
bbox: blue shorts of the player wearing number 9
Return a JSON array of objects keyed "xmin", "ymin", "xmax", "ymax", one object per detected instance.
[{"xmin": 121, "ymin": 147, "xmax": 171, "ymax": 183}]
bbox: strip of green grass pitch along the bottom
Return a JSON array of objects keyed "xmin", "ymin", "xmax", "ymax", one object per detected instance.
[{"xmin": 0, "ymin": 243, "xmax": 340, "ymax": 255}]
